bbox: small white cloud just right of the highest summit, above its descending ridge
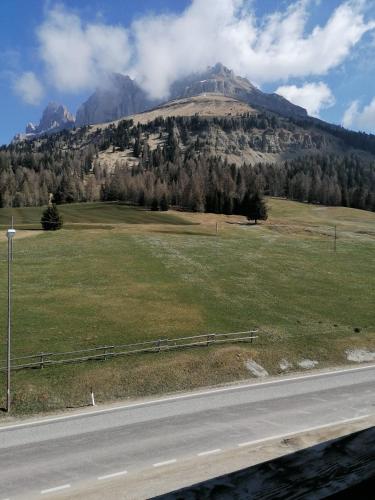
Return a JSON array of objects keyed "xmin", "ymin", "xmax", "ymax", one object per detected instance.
[{"xmin": 276, "ymin": 82, "xmax": 335, "ymax": 116}]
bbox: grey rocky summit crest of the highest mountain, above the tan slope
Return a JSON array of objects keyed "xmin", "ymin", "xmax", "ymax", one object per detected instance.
[{"xmin": 171, "ymin": 63, "xmax": 307, "ymax": 117}]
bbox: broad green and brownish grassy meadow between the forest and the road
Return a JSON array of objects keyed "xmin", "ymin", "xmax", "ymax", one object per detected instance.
[{"xmin": 0, "ymin": 199, "xmax": 375, "ymax": 412}]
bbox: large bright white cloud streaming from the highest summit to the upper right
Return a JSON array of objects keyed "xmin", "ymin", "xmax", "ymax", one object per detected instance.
[{"xmin": 132, "ymin": 0, "xmax": 375, "ymax": 97}]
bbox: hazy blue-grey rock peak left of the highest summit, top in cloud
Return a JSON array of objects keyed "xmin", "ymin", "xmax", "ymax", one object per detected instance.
[{"xmin": 76, "ymin": 74, "xmax": 156, "ymax": 126}]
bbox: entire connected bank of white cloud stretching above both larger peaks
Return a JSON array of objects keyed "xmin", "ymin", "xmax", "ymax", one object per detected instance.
[{"xmin": 16, "ymin": 0, "xmax": 375, "ymax": 98}]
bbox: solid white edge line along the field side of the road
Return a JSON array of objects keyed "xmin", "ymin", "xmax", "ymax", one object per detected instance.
[{"xmin": 0, "ymin": 365, "xmax": 375, "ymax": 432}]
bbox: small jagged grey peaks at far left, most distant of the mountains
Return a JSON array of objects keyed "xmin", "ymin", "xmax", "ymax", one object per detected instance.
[{"xmin": 15, "ymin": 102, "xmax": 75, "ymax": 140}]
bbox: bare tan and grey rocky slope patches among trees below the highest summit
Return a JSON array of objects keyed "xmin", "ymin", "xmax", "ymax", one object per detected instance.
[{"xmin": 94, "ymin": 93, "xmax": 343, "ymax": 170}]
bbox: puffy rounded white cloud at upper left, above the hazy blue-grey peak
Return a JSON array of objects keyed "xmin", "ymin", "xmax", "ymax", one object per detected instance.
[{"xmin": 37, "ymin": 7, "xmax": 130, "ymax": 92}]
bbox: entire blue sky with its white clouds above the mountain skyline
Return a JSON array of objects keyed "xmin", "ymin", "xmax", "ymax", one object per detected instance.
[{"xmin": 0, "ymin": 0, "xmax": 375, "ymax": 144}]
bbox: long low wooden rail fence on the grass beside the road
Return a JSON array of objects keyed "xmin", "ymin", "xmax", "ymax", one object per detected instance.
[{"xmin": 0, "ymin": 330, "xmax": 258, "ymax": 371}]
